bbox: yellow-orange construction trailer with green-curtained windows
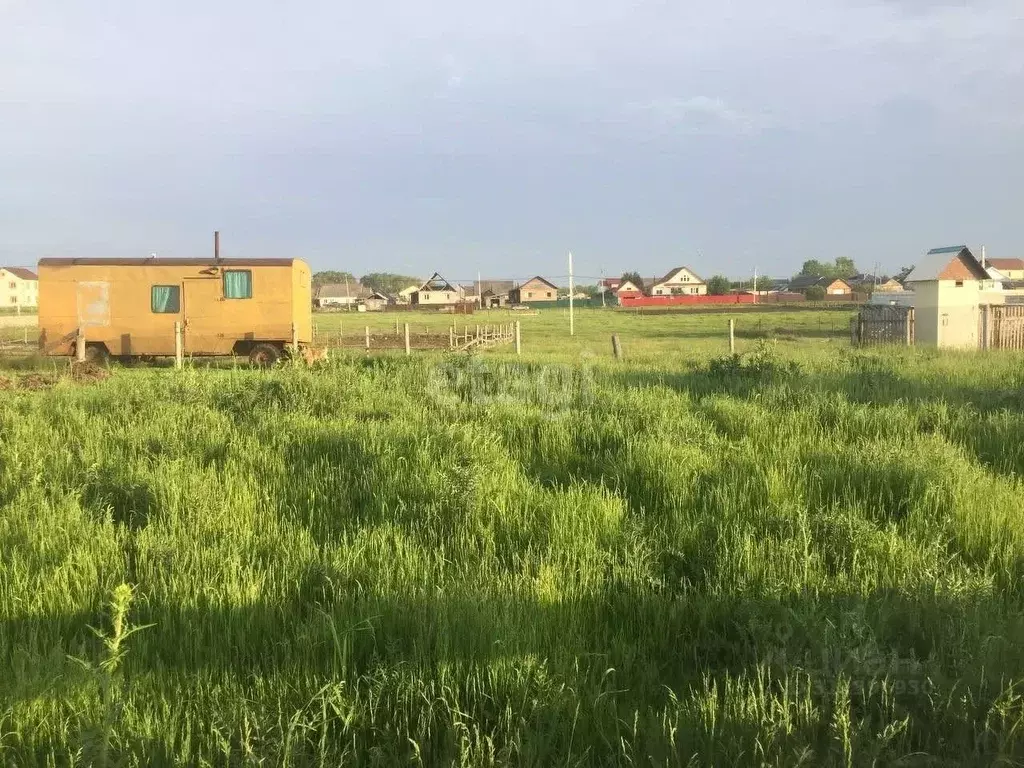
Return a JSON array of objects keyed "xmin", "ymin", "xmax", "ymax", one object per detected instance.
[{"xmin": 39, "ymin": 257, "xmax": 312, "ymax": 365}]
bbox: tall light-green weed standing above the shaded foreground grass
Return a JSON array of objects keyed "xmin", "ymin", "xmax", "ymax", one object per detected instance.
[{"xmin": 71, "ymin": 584, "xmax": 153, "ymax": 766}]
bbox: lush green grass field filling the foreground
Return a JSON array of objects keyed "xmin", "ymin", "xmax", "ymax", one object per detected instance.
[{"xmin": 0, "ymin": 310, "xmax": 1024, "ymax": 766}]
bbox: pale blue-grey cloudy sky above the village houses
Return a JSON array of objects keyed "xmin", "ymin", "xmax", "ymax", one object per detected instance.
[{"xmin": 0, "ymin": 0, "xmax": 1024, "ymax": 282}]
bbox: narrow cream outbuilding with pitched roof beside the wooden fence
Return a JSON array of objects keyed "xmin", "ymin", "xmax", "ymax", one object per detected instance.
[{"xmin": 904, "ymin": 246, "xmax": 990, "ymax": 348}]
